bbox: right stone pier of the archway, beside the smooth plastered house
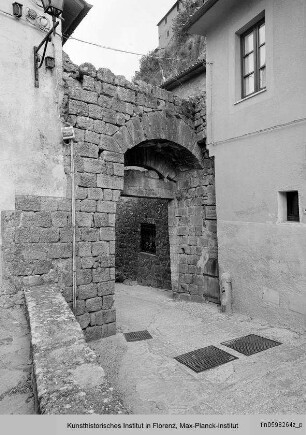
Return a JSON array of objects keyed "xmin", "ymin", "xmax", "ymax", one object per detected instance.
[{"xmin": 169, "ymin": 155, "xmax": 219, "ymax": 302}]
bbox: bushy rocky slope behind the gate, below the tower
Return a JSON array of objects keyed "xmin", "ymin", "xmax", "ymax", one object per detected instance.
[{"xmin": 134, "ymin": 0, "xmax": 206, "ymax": 86}]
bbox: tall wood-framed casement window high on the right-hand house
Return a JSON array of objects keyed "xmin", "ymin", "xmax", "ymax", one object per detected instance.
[{"xmin": 241, "ymin": 19, "xmax": 266, "ymax": 98}]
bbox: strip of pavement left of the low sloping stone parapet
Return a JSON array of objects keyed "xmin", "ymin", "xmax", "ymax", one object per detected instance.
[{"xmin": 0, "ymin": 308, "xmax": 35, "ymax": 415}]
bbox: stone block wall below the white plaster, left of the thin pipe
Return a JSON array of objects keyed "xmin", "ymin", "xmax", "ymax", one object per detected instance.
[{"xmin": 1, "ymin": 196, "xmax": 72, "ymax": 306}]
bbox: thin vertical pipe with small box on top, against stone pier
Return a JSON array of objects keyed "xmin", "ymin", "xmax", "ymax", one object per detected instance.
[{"xmin": 62, "ymin": 124, "xmax": 77, "ymax": 315}]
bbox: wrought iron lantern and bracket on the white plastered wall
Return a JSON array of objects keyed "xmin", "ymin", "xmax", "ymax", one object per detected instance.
[{"xmin": 34, "ymin": 0, "xmax": 64, "ymax": 88}]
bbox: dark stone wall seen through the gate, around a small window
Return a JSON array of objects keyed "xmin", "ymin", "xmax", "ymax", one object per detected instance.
[{"xmin": 116, "ymin": 197, "xmax": 171, "ymax": 290}]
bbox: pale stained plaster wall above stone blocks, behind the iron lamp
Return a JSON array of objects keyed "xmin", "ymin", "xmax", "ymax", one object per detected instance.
[{"xmin": 0, "ymin": 0, "xmax": 66, "ymax": 284}]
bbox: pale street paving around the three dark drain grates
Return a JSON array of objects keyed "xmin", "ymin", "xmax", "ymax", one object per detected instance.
[{"xmin": 91, "ymin": 284, "xmax": 306, "ymax": 415}]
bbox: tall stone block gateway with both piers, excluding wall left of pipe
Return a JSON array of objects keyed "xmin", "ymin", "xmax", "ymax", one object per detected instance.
[{"xmin": 59, "ymin": 58, "xmax": 218, "ymax": 339}]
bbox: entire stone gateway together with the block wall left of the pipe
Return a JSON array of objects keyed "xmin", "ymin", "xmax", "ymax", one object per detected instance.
[{"xmin": 2, "ymin": 58, "xmax": 219, "ymax": 340}]
